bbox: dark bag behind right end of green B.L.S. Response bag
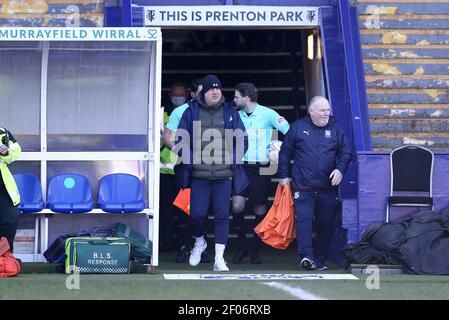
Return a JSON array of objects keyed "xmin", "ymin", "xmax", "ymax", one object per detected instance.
[{"xmin": 113, "ymin": 223, "xmax": 153, "ymax": 263}]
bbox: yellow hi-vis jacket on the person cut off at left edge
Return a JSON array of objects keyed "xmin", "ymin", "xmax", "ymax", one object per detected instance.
[{"xmin": 0, "ymin": 132, "xmax": 22, "ymax": 206}]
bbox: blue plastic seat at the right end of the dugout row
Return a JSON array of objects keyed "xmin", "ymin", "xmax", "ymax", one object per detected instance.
[{"xmin": 98, "ymin": 173, "xmax": 145, "ymax": 213}]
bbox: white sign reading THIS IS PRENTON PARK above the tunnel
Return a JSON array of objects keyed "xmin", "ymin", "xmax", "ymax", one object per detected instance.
[{"xmin": 143, "ymin": 6, "xmax": 318, "ymax": 27}]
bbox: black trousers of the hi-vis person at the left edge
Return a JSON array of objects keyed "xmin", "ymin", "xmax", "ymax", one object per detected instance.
[{"xmin": 0, "ymin": 193, "xmax": 20, "ymax": 251}]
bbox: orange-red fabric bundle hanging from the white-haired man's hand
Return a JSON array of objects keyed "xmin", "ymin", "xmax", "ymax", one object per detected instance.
[{"xmin": 254, "ymin": 184, "xmax": 296, "ymax": 249}]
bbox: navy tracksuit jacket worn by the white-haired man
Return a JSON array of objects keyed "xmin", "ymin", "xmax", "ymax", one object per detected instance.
[{"xmin": 278, "ymin": 115, "xmax": 352, "ymax": 191}]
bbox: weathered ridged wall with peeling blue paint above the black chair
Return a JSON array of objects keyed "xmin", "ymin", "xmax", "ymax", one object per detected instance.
[{"xmin": 358, "ymin": 0, "xmax": 449, "ymax": 150}]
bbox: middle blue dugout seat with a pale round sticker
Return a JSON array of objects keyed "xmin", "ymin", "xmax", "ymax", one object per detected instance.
[{"xmin": 47, "ymin": 174, "xmax": 94, "ymax": 213}]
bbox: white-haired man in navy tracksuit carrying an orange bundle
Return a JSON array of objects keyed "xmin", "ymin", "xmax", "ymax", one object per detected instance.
[{"xmin": 278, "ymin": 96, "xmax": 352, "ymax": 270}]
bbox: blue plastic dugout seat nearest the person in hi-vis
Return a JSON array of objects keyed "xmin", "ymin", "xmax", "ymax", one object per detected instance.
[{"xmin": 14, "ymin": 173, "xmax": 45, "ymax": 213}]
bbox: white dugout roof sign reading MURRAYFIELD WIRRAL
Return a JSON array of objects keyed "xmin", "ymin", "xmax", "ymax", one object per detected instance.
[{"xmin": 0, "ymin": 27, "xmax": 161, "ymax": 41}]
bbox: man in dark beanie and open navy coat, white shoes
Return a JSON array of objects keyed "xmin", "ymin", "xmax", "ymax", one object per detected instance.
[{"xmin": 175, "ymin": 75, "xmax": 248, "ymax": 271}]
